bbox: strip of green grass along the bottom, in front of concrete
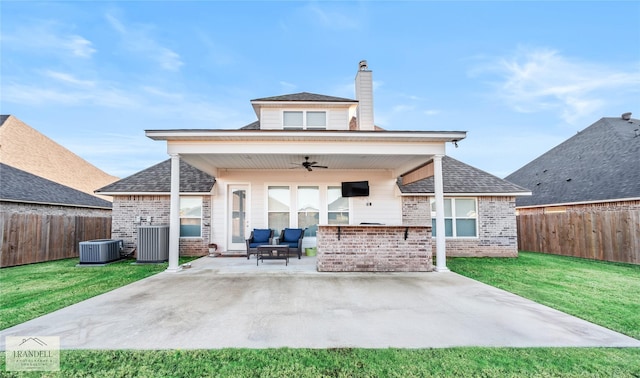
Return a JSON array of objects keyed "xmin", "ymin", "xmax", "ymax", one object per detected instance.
[{"xmin": 0, "ymin": 348, "xmax": 640, "ymax": 378}]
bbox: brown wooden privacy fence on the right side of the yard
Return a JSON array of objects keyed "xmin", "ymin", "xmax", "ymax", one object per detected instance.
[{"xmin": 517, "ymin": 209, "xmax": 640, "ymax": 264}]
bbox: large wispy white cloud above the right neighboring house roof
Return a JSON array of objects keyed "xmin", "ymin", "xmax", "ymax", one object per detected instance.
[{"xmin": 471, "ymin": 48, "xmax": 640, "ymax": 124}]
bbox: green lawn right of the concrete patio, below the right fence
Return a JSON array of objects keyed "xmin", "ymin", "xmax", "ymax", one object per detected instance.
[{"xmin": 448, "ymin": 252, "xmax": 640, "ymax": 339}]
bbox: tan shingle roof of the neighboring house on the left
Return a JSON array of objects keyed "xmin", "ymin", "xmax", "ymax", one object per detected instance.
[{"xmin": 0, "ymin": 115, "xmax": 118, "ymax": 199}]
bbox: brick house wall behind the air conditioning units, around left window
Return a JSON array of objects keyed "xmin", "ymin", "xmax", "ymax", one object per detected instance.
[{"xmin": 111, "ymin": 195, "xmax": 211, "ymax": 256}]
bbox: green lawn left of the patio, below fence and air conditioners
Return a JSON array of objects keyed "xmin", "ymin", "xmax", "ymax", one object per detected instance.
[{"xmin": 0, "ymin": 258, "xmax": 192, "ymax": 329}]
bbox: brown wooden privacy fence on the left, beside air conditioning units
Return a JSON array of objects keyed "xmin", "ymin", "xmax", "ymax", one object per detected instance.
[{"xmin": 0, "ymin": 212, "xmax": 111, "ymax": 267}]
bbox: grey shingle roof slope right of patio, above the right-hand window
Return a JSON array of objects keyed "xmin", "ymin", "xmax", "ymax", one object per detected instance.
[{"xmin": 398, "ymin": 156, "xmax": 530, "ymax": 195}]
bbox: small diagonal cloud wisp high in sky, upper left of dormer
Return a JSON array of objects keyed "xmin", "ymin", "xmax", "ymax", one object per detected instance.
[{"xmin": 105, "ymin": 13, "xmax": 184, "ymax": 71}]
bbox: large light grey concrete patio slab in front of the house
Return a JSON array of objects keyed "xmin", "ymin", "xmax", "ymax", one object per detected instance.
[{"xmin": 0, "ymin": 257, "xmax": 640, "ymax": 350}]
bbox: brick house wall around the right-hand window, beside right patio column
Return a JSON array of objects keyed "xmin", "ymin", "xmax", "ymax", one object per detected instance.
[{"xmin": 402, "ymin": 197, "xmax": 518, "ymax": 257}]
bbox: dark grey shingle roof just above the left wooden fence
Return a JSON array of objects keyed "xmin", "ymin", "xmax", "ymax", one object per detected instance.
[{"xmin": 0, "ymin": 163, "xmax": 111, "ymax": 209}]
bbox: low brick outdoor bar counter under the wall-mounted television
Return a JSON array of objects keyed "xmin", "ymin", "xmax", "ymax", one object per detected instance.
[{"xmin": 317, "ymin": 226, "xmax": 433, "ymax": 272}]
